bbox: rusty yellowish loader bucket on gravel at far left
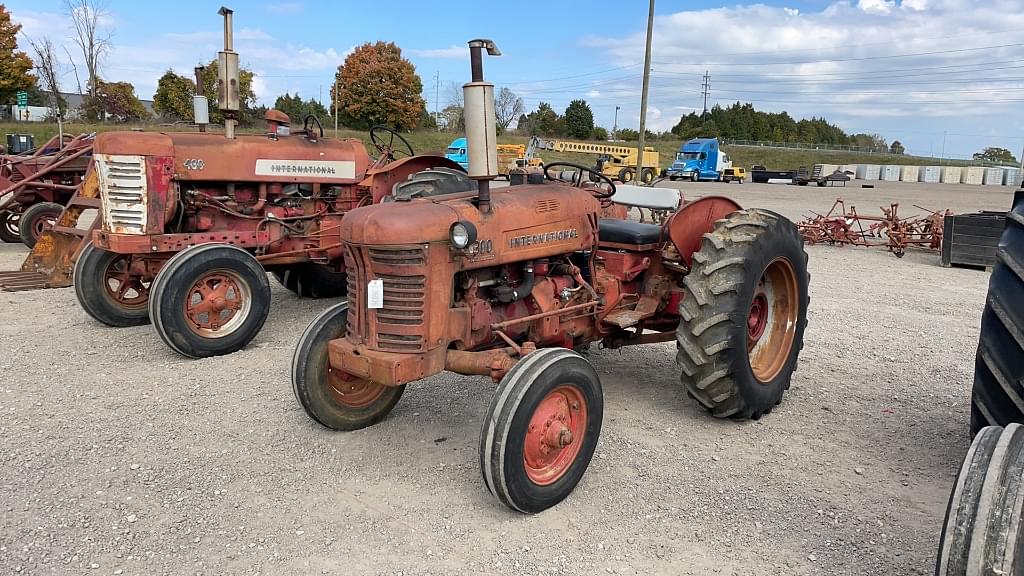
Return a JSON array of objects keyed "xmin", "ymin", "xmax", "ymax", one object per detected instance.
[{"xmin": 0, "ymin": 165, "xmax": 101, "ymax": 292}]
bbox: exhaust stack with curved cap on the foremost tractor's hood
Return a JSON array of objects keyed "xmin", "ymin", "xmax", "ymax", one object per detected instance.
[{"xmin": 462, "ymin": 39, "xmax": 502, "ymax": 213}]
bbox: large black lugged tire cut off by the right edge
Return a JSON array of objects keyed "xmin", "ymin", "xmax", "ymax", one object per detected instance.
[{"xmin": 971, "ymin": 192, "xmax": 1024, "ymax": 434}]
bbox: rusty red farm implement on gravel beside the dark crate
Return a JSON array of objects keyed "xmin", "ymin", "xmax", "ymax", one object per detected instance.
[{"xmin": 797, "ymin": 198, "xmax": 952, "ymax": 257}]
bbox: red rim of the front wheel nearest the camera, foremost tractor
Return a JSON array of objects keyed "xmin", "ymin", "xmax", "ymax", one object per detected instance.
[{"xmin": 522, "ymin": 384, "xmax": 587, "ymax": 486}]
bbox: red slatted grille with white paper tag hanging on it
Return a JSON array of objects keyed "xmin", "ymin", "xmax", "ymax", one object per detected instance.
[{"xmin": 345, "ymin": 241, "xmax": 427, "ymax": 353}]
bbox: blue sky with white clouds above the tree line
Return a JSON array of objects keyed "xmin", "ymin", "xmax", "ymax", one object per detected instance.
[{"xmin": 12, "ymin": 0, "xmax": 1024, "ymax": 158}]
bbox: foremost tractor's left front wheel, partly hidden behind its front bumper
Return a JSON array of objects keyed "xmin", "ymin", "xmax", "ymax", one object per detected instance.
[{"xmin": 292, "ymin": 302, "xmax": 406, "ymax": 430}]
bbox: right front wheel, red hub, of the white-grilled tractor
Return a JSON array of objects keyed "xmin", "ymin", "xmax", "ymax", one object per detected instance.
[{"xmin": 150, "ymin": 244, "xmax": 270, "ymax": 358}]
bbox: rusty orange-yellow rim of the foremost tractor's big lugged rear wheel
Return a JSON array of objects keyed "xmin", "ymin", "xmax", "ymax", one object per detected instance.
[{"xmin": 746, "ymin": 257, "xmax": 800, "ymax": 384}]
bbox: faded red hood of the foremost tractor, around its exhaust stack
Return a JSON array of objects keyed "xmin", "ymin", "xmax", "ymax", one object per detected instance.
[{"xmin": 340, "ymin": 182, "xmax": 601, "ymax": 270}]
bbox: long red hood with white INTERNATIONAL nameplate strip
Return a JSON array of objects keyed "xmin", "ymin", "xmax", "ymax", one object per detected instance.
[{"xmin": 93, "ymin": 132, "xmax": 370, "ymax": 183}]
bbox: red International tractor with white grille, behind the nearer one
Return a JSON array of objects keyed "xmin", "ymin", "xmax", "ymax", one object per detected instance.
[{"xmin": 74, "ymin": 9, "xmax": 458, "ymax": 358}]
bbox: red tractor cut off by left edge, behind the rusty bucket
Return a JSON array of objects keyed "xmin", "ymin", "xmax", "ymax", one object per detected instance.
[{"xmin": 0, "ymin": 134, "xmax": 92, "ymax": 248}]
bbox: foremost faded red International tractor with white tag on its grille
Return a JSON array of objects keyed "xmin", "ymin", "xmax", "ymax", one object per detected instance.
[{"xmin": 292, "ymin": 40, "xmax": 808, "ymax": 513}]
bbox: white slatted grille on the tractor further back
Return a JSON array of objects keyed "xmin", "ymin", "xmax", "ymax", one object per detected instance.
[{"xmin": 94, "ymin": 154, "xmax": 146, "ymax": 234}]
